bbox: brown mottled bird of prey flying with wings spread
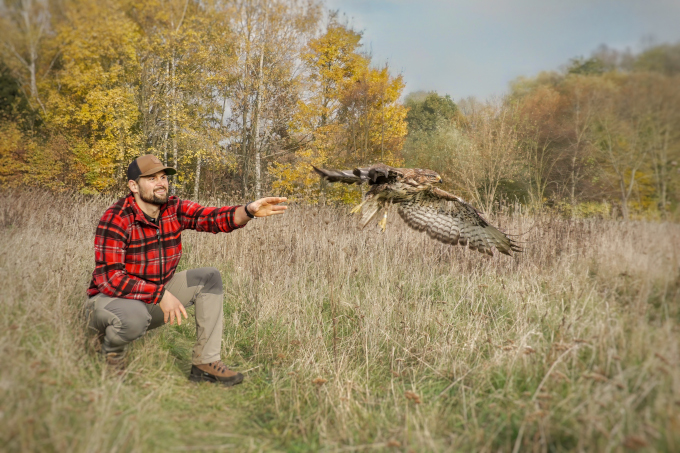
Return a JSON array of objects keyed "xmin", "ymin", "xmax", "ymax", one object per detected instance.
[{"xmin": 313, "ymin": 164, "xmax": 522, "ymax": 255}]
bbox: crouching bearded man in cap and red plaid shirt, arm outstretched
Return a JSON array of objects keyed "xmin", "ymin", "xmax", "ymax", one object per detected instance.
[{"xmin": 87, "ymin": 155, "xmax": 286, "ymax": 385}]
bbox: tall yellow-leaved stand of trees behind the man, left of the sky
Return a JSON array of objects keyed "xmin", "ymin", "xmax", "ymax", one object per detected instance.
[{"xmin": 0, "ymin": 0, "xmax": 406, "ymax": 197}]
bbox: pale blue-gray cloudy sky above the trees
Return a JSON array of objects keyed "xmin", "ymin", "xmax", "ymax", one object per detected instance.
[{"xmin": 326, "ymin": 0, "xmax": 680, "ymax": 101}]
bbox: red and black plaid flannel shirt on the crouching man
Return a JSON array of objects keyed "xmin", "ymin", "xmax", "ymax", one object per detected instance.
[{"xmin": 87, "ymin": 193, "xmax": 243, "ymax": 304}]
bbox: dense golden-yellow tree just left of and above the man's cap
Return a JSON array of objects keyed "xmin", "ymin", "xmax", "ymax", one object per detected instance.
[{"xmin": 45, "ymin": 0, "xmax": 139, "ymax": 191}]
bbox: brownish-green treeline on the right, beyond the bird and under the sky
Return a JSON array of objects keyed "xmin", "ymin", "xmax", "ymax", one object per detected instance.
[{"xmin": 403, "ymin": 44, "xmax": 680, "ymax": 219}]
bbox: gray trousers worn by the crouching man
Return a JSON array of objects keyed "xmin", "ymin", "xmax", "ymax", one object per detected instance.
[{"xmin": 86, "ymin": 267, "xmax": 223, "ymax": 365}]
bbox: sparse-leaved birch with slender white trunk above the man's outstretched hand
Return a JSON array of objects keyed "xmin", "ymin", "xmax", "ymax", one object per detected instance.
[{"xmin": 223, "ymin": 0, "xmax": 321, "ymax": 196}]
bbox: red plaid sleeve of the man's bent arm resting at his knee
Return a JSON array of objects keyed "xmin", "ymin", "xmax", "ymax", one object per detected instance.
[{"xmin": 93, "ymin": 209, "xmax": 165, "ymax": 304}]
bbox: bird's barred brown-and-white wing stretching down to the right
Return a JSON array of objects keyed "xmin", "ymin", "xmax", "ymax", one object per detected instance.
[{"xmin": 399, "ymin": 188, "xmax": 522, "ymax": 255}]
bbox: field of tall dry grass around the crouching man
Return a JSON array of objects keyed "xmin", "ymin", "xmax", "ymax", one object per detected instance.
[{"xmin": 0, "ymin": 192, "xmax": 680, "ymax": 452}]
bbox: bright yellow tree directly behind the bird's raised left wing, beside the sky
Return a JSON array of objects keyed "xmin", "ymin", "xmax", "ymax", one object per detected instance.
[{"xmin": 272, "ymin": 16, "xmax": 407, "ymax": 201}]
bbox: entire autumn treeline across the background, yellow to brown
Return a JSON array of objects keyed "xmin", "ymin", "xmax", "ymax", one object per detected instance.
[{"xmin": 0, "ymin": 0, "xmax": 680, "ymax": 218}]
